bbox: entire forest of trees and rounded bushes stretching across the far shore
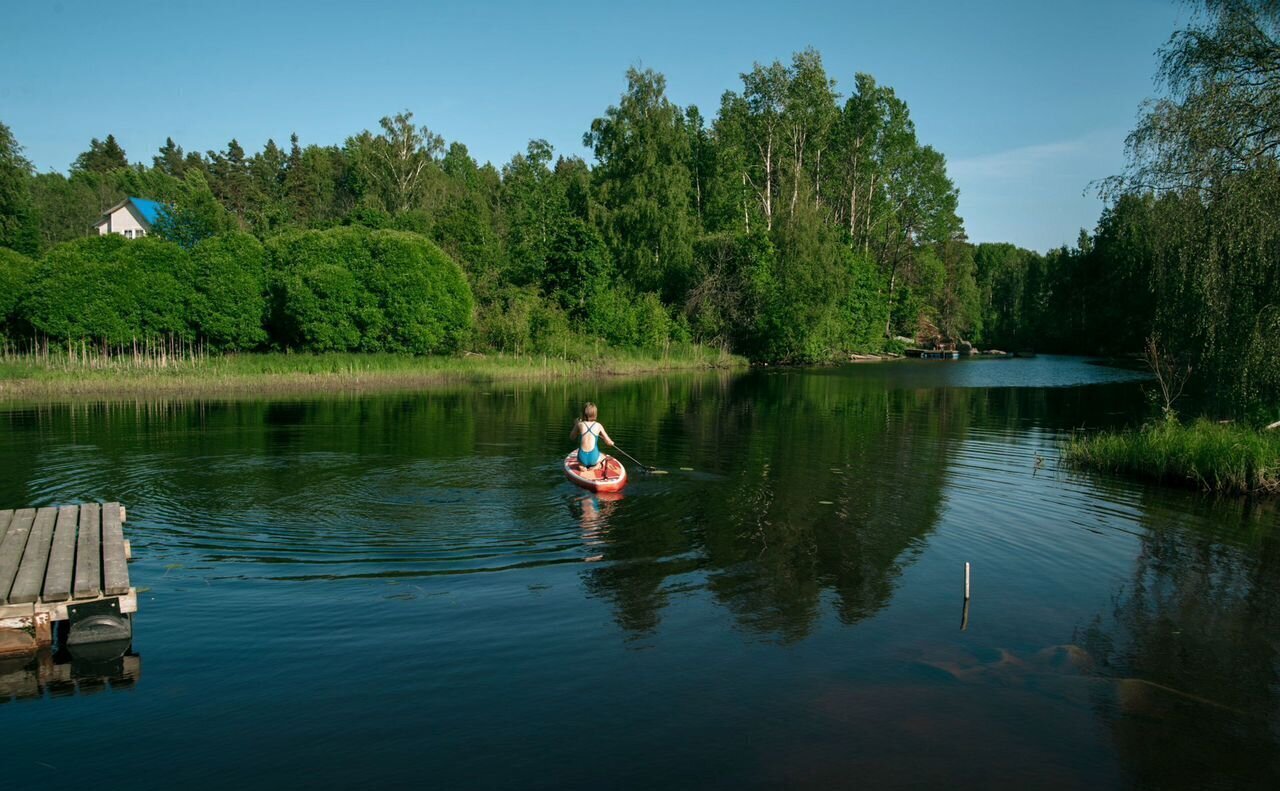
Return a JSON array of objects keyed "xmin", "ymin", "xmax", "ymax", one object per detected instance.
[{"xmin": 0, "ymin": 0, "xmax": 1280, "ymax": 416}]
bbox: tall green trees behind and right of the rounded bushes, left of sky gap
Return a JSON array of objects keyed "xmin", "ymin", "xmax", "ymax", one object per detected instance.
[{"xmin": 0, "ymin": 50, "xmax": 982, "ymax": 361}]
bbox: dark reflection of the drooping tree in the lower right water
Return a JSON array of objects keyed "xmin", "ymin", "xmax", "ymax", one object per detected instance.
[{"xmin": 1084, "ymin": 493, "xmax": 1280, "ymax": 787}]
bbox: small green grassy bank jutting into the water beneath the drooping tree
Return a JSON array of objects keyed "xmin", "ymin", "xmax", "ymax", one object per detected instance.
[{"xmin": 1062, "ymin": 420, "xmax": 1280, "ymax": 494}]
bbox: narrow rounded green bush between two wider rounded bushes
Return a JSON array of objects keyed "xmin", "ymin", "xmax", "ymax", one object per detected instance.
[{"xmin": 191, "ymin": 233, "xmax": 268, "ymax": 351}]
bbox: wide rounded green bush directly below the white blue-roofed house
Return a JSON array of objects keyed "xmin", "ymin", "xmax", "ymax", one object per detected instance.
[{"xmin": 19, "ymin": 234, "xmax": 195, "ymax": 346}]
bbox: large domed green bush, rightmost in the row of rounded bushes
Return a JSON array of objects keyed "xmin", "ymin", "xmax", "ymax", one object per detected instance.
[{"xmin": 266, "ymin": 227, "xmax": 472, "ymax": 355}]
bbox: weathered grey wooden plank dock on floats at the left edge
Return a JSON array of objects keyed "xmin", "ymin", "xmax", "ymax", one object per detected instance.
[{"xmin": 0, "ymin": 503, "xmax": 138, "ymax": 657}]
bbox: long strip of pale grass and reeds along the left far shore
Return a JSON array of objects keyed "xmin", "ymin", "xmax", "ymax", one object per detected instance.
[{"xmin": 0, "ymin": 346, "xmax": 746, "ymax": 399}]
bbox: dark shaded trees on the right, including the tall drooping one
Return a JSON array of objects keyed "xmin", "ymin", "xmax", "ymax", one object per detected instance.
[{"xmin": 975, "ymin": 0, "xmax": 1280, "ymax": 422}]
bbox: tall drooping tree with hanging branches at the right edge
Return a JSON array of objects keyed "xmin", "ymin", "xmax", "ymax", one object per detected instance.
[{"xmin": 1095, "ymin": 0, "xmax": 1280, "ymax": 413}]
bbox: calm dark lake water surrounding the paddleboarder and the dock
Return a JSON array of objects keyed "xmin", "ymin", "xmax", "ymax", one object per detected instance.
[{"xmin": 0, "ymin": 358, "xmax": 1280, "ymax": 788}]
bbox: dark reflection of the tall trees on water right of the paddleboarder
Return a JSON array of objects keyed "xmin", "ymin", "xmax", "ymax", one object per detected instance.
[{"xmin": 586, "ymin": 375, "xmax": 972, "ymax": 643}]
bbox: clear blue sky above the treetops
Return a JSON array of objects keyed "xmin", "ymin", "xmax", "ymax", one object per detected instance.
[{"xmin": 0, "ymin": 0, "xmax": 1189, "ymax": 250}]
